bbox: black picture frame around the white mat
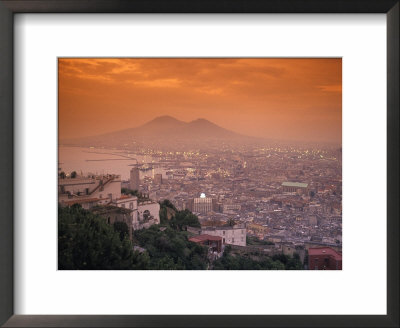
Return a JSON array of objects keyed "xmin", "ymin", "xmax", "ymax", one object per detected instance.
[{"xmin": 0, "ymin": 0, "xmax": 400, "ymax": 327}]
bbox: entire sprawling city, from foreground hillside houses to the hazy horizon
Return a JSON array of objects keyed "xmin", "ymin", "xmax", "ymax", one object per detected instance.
[{"xmin": 59, "ymin": 118, "xmax": 342, "ymax": 268}]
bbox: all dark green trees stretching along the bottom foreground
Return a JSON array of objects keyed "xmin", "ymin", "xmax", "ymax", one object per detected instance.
[{"xmin": 58, "ymin": 201, "xmax": 302, "ymax": 270}]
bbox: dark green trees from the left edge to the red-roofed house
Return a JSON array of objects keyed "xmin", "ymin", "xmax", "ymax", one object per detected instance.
[{"xmin": 58, "ymin": 205, "xmax": 208, "ymax": 270}]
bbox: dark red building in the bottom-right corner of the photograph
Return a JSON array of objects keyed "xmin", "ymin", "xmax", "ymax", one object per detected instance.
[{"xmin": 308, "ymin": 247, "xmax": 342, "ymax": 270}]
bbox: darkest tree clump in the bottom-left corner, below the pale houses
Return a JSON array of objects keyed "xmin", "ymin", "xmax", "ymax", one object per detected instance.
[{"xmin": 58, "ymin": 205, "xmax": 146, "ymax": 270}]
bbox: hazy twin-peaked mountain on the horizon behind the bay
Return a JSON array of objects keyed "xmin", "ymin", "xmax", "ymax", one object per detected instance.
[{"xmin": 60, "ymin": 116, "xmax": 256, "ymax": 148}]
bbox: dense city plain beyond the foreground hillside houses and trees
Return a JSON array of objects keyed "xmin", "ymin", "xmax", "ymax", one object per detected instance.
[{"xmin": 123, "ymin": 140, "xmax": 342, "ymax": 246}]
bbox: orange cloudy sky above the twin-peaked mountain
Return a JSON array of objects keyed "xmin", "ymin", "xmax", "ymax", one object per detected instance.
[{"xmin": 59, "ymin": 58, "xmax": 342, "ymax": 143}]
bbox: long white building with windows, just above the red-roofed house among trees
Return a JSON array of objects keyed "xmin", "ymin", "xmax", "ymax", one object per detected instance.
[{"xmin": 187, "ymin": 225, "xmax": 246, "ymax": 246}]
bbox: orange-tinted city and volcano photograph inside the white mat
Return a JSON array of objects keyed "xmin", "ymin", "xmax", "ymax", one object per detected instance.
[{"xmin": 58, "ymin": 58, "xmax": 342, "ymax": 270}]
